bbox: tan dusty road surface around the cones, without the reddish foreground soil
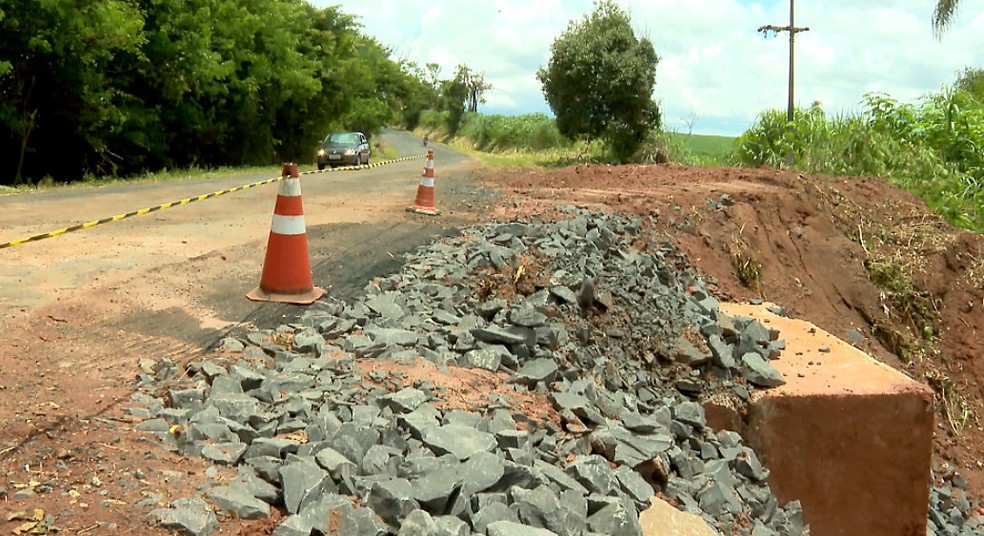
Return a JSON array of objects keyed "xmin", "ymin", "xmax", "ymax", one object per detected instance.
[{"xmin": 0, "ymin": 131, "xmax": 494, "ymax": 371}]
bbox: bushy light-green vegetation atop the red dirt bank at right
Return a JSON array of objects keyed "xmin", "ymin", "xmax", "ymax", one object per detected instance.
[{"xmin": 734, "ymin": 69, "xmax": 984, "ymax": 233}]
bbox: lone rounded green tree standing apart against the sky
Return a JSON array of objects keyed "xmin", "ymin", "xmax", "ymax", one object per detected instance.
[{"xmin": 537, "ymin": 0, "xmax": 660, "ymax": 161}]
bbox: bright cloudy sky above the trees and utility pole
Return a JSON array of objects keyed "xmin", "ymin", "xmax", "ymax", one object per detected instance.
[{"xmin": 318, "ymin": 0, "xmax": 984, "ymax": 136}]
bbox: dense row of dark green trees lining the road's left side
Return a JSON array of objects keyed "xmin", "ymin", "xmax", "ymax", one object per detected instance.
[{"xmin": 0, "ymin": 0, "xmax": 435, "ymax": 184}]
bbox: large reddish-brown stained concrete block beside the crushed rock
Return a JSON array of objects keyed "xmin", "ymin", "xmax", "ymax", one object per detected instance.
[{"xmin": 721, "ymin": 304, "xmax": 934, "ymax": 536}]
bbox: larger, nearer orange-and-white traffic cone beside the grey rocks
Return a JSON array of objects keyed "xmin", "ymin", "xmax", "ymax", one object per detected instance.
[{"xmin": 246, "ymin": 164, "xmax": 325, "ymax": 305}]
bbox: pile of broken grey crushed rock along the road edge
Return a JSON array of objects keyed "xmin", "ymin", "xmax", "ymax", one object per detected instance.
[{"xmin": 131, "ymin": 208, "xmax": 971, "ymax": 536}]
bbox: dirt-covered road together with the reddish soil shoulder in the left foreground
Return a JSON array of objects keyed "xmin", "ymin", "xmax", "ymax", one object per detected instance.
[{"xmin": 0, "ymin": 132, "xmax": 493, "ymax": 533}]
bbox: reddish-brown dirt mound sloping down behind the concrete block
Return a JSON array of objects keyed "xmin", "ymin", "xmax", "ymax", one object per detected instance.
[{"xmin": 485, "ymin": 165, "xmax": 984, "ymax": 499}]
